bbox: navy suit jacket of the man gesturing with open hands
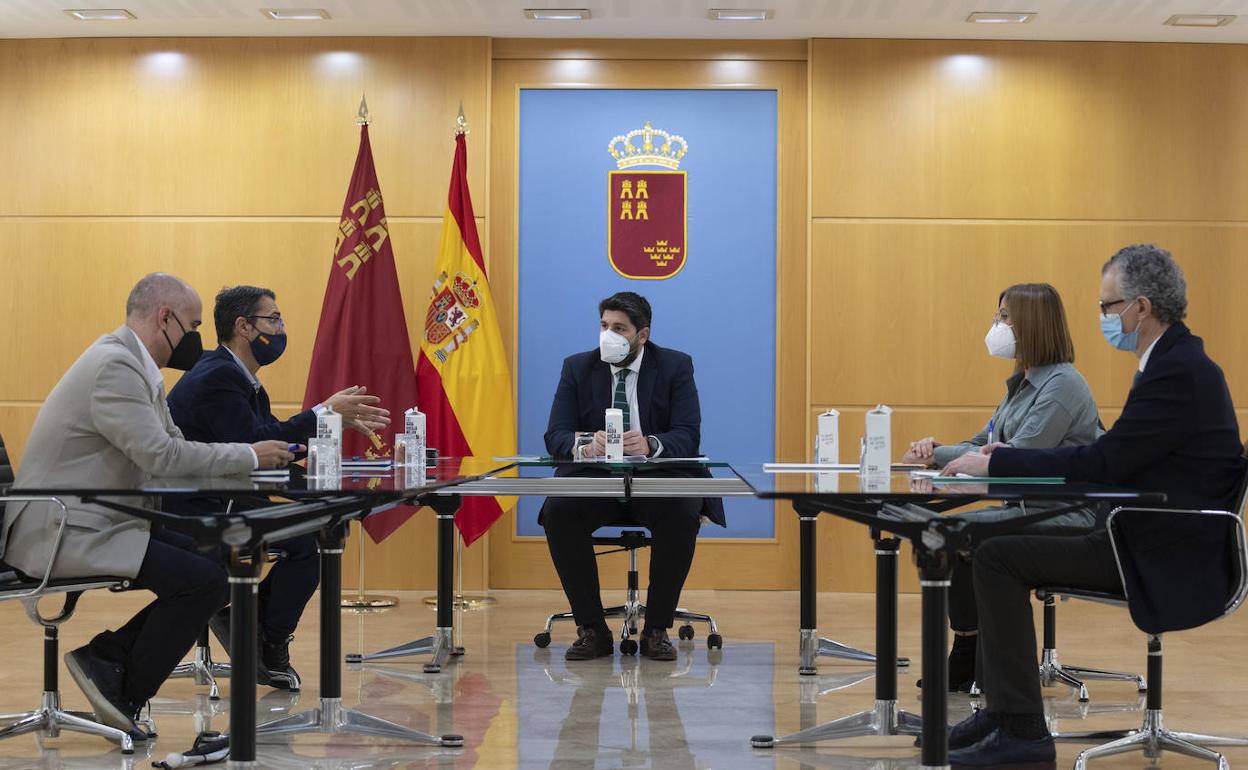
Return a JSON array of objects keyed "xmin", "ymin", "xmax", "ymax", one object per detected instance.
[{"xmin": 168, "ymin": 347, "xmax": 316, "ymax": 444}]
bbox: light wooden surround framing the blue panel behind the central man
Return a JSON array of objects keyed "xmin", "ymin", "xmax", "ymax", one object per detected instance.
[{"xmin": 489, "ymin": 40, "xmax": 807, "ymax": 588}]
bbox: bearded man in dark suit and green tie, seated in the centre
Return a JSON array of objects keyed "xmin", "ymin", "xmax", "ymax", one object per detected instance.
[{"xmin": 540, "ymin": 292, "xmax": 724, "ymax": 660}]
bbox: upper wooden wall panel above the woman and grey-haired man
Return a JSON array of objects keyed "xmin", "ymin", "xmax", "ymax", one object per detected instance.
[{"xmin": 811, "ymin": 40, "xmax": 1248, "ymax": 221}]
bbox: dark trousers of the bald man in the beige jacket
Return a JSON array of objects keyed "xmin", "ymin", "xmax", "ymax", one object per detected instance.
[{"xmin": 91, "ymin": 530, "xmax": 230, "ymax": 708}]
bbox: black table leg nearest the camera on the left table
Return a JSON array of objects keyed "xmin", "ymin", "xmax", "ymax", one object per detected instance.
[{"xmin": 228, "ymin": 547, "xmax": 265, "ymax": 770}]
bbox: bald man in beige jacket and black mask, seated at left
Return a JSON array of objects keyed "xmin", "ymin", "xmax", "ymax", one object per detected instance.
[{"xmin": 0, "ymin": 273, "xmax": 293, "ymax": 740}]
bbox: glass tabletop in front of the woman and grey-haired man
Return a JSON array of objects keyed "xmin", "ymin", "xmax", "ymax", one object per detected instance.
[{"xmin": 733, "ymin": 461, "xmax": 1166, "ymax": 503}]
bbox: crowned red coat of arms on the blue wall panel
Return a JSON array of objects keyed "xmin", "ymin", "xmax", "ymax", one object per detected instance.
[{"xmin": 607, "ymin": 121, "xmax": 689, "ymax": 281}]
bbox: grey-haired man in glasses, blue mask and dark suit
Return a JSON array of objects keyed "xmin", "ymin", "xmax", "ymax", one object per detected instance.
[{"xmin": 945, "ymin": 245, "xmax": 1244, "ymax": 766}]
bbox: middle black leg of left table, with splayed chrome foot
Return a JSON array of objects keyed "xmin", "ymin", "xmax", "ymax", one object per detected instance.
[{"xmin": 255, "ymin": 523, "xmax": 464, "ymax": 746}]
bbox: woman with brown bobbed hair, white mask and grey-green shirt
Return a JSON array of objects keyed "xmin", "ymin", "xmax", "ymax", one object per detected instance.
[{"xmin": 904, "ymin": 283, "xmax": 1103, "ymax": 691}]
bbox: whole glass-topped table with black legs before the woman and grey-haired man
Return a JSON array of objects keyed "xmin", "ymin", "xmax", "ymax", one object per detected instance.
[{"xmin": 734, "ymin": 463, "xmax": 1164, "ymax": 768}]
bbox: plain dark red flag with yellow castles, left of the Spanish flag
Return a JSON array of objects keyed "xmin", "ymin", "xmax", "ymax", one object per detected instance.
[{"xmin": 303, "ymin": 125, "xmax": 419, "ymax": 543}]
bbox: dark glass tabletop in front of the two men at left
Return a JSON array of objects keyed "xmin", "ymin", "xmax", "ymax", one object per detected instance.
[{"xmin": 6, "ymin": 457, "xmax": 510, "ymax": 499}]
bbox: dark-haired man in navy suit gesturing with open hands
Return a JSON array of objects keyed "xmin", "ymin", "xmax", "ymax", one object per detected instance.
[{"xmin": 168, "ymin": 286, "xmax": 389, "ymax": 689}]
